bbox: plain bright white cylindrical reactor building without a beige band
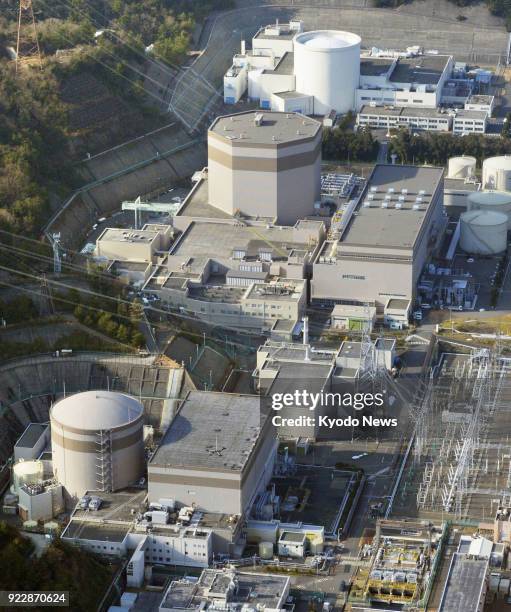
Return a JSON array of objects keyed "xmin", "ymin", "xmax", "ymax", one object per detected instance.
[{"xmin": 294, "ymin": 30, "xmax": 361, "ymax": 115}]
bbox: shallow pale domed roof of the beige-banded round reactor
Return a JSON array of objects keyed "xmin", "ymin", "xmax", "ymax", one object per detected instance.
[{"xmin": 51, "ymin": 391, "xmax": 144, "ymax": 431}]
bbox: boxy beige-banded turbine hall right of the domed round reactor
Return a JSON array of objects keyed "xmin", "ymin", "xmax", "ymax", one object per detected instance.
[{"xmin": 148, "ymin": 391, "xmax": 277, "ymax": 515}]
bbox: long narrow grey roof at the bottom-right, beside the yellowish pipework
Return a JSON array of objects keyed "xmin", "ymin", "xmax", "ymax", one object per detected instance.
[{"xmin": 438, "ymin": 553, "xmax": 488, "ymax": 612}]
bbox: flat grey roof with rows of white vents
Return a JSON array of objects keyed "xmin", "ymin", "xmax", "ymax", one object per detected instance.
[{"xmin": 338, "ymin": 164, "xmax": 443, "ymax": 250}]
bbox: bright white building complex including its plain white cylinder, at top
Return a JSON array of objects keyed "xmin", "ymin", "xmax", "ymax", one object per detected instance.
[{"xmin": 224, "ymin": 21, "xmax": 494, "ymax": 134}]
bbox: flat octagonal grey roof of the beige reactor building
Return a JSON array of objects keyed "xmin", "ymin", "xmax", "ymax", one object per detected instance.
[{"xmin": 209, "ymin": 111, "xmax": 321, "ymax": 147}]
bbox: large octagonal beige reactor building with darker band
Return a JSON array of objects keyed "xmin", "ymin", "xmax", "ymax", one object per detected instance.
[{"xmin": 208, "ymin": 111, "xmax": 322, "ymax": 225}]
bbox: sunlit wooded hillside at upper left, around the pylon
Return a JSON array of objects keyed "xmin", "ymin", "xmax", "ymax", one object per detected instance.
[{"xmin": 0, "ymin": 0, "xmax": 233, "ymax": 235}]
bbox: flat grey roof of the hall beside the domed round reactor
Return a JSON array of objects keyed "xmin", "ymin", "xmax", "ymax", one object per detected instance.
[{"xmin": 149, "ymin": 391, "xmax": 261, "ymax": 472}]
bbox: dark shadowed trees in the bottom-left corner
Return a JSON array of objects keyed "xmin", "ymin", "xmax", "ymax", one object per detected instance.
[{"xmin": 0, "ymin": 521, "xmax": 111, "ymax": 612}]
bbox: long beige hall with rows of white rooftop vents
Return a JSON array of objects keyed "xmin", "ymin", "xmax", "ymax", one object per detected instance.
[{"xmin": 311, "ymin": 164, "xmax": 447, "ymax": 314}]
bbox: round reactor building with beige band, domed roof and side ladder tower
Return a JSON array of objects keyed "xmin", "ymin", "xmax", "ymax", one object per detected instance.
[{"xmin": 50, "ymin": 391, "xmax": 144, "ymax": 499}]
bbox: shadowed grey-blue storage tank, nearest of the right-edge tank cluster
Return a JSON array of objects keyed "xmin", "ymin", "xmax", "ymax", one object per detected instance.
[{"xmin": 460, "ymin": 210, "xmax": 507, "ymax": 255}]
